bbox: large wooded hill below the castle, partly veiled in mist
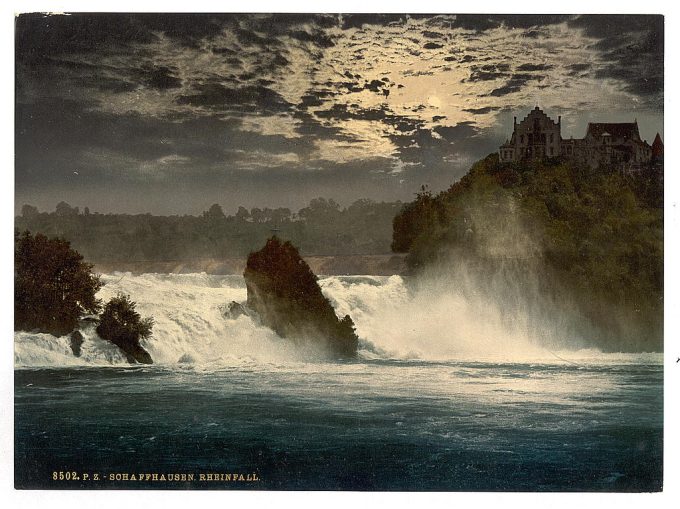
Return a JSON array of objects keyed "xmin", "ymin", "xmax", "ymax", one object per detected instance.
[{"xmin": 392, "ymin": 154, "xmax": 663, "ymax": 351}]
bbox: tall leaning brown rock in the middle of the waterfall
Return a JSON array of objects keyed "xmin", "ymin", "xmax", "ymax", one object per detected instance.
[{"xmin": 244, "ymin": 237, "xmax": 359, "ymax": 357}]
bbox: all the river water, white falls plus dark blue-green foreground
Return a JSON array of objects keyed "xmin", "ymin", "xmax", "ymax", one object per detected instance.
[{"xmin": 15, "ymin": 274, "xmax": 663, "ymax": 491}]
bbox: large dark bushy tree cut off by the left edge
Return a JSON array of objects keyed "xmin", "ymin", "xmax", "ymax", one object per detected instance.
[{"xmin": 14, "ymin": 230, "xmax": 102, "ymax": 336}]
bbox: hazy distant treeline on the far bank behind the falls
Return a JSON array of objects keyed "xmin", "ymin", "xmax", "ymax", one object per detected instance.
[{"xmin": 15, "ymin": 198, "xmax": 402, "ymax": 263}]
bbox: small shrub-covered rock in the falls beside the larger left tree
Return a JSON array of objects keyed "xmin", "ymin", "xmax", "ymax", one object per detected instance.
[{"xmin": 97, "ymin": 293, "xmax": 153, "ymax": 364}]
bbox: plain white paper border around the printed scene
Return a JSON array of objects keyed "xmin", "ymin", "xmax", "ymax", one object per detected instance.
[{"xmin": 0, "ymin": 0, "xmax": 680, "ymax": 509}]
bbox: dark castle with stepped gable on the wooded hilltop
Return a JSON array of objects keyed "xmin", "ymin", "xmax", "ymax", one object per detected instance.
[{"xmin": 498, "ymin": 106, "xmax": 663, "ymax": 172}]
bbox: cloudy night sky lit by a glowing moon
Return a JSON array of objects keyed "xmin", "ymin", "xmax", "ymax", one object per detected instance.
[{"xmin": 15, "ymin": 14, "xmax": 664, "ymax": 214}]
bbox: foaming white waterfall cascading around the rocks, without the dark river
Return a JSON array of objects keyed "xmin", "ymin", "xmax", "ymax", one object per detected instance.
[{"xmin": 15, "ymin": 273, "xmax": 660, "ymax": 367}]
